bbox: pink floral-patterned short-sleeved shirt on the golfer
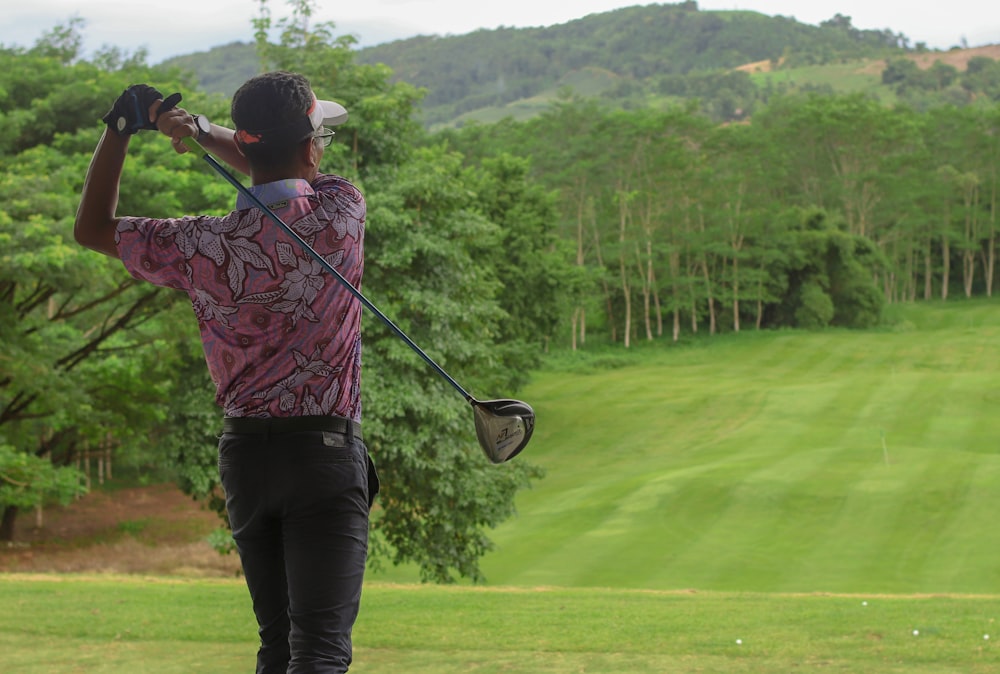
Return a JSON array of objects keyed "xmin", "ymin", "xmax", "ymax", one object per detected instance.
[{"xmin": 117, "ymin": 175, "xmax": 365, "ymax": 421}]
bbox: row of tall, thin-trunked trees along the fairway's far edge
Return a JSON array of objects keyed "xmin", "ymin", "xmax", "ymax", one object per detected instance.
[{"xmin": 437, "ymin": 93, "xmax": 1000, "ymax": 346}]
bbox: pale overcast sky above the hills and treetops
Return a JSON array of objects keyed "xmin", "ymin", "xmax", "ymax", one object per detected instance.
[{"xmin": 0, "ymin": 0, "xmax": 1000, "ymax": 63}]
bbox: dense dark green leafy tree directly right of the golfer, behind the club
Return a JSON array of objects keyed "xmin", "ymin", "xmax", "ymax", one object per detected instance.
[{"xmin": 362, "ymin": 148, "xmax": 538, "ymax": 582}]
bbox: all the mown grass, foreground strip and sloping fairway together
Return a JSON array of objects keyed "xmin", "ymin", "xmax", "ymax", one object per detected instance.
[{"xmin": 0, "ymin": 300, "xmax": 1000, "ymax": 674}]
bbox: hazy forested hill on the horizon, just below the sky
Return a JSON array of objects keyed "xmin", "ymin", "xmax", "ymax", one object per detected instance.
[{"xmin": 164, "ymin": 1, "xmax": 920, "ymax": 126}]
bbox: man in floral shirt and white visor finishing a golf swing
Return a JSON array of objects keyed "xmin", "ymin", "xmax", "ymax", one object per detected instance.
[{"xmin": 75, "ymin": 72, "xmax": 378, "ymax": 674}]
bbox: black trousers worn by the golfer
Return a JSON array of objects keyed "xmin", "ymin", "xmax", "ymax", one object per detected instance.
[{"xmin": 219, "ymin": 422, "xmax": 378, "ymax": 674}]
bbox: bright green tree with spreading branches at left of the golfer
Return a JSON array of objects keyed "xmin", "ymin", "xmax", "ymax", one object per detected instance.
[{"xmin": 0, "ymin": 23, "xmax": 230, "ymax": 536}]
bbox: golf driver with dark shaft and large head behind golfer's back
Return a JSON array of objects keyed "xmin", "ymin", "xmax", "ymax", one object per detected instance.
[{"xmin": 178, "ymin": 136, "xmax": 535, "ymax": 463}]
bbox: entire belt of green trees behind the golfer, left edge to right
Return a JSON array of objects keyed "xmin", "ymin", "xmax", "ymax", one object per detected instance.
[{"xmin": 0, "ymin": 2, "xmax": 1000, "ymax": 581}]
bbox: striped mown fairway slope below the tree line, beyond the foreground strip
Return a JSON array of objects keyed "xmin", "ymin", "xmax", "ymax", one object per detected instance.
[{"xmin": 376, "ymin": 301, "xmax": 1000, "ymax": 593}]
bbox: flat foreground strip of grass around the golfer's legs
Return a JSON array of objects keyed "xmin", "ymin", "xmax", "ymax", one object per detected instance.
[{"xmin": 0, "ymin": 575, "xmax": 1000, "ymax": 674}]
